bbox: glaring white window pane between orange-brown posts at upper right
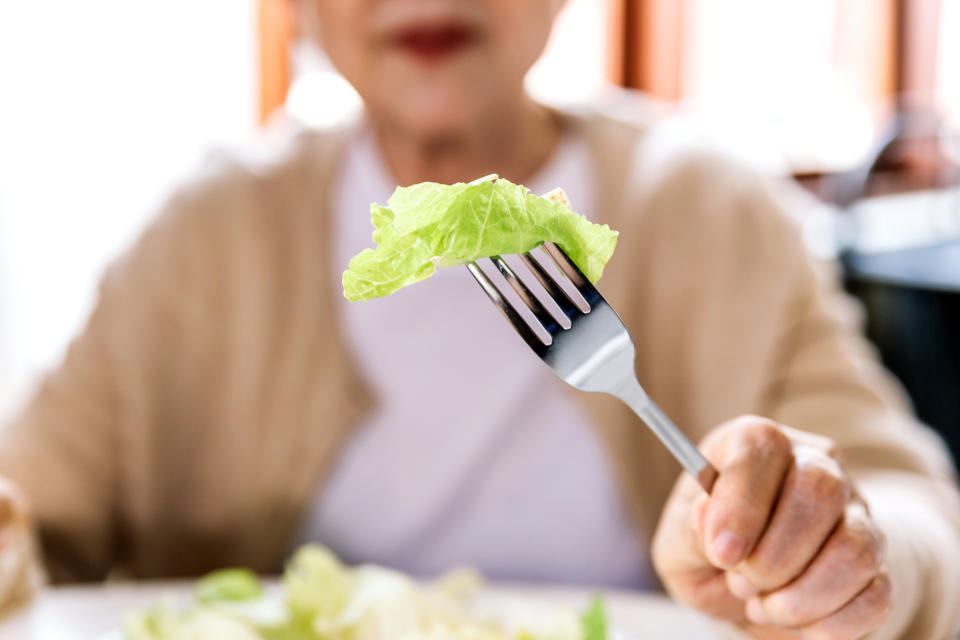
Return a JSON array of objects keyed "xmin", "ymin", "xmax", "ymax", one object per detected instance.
[{"xmin": 682, "ymin": 0, "xmax": 889, "ymax": 173}]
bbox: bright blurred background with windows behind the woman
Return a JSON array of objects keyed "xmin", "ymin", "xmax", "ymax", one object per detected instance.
[{"xmin": 0, "ymin": 0, "xmax": 960, "ymax": 455}]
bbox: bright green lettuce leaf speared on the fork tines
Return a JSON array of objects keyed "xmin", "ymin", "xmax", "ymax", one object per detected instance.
[{"xmin": 343, "ymin": 176, "xmax": 618, "ymax": 301}]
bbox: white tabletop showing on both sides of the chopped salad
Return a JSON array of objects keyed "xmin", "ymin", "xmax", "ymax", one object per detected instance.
[{"xmin": 0, "ymin": 582, "xmax": 719, "ymax": 640}]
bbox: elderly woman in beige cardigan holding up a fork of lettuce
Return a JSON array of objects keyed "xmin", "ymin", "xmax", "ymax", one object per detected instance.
[{"xmin": 0, "ymin": 0, "xmax": 960, "ymax": 640}]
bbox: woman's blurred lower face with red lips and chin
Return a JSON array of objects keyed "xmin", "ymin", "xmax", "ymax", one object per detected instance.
[{"xmin": 313, "ymin": 0, "xmax": 562, "ymax": 136}]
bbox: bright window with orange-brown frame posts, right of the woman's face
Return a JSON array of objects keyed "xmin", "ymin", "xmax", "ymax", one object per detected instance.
[{"xmin": 613, "ymin": 0, "xmax": 960, "ymax": 175}]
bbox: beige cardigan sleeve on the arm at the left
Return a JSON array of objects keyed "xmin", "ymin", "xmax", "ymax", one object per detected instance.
[{"xmin": 0, "ymin": 170, "xmax": 221, "ymax": 597}]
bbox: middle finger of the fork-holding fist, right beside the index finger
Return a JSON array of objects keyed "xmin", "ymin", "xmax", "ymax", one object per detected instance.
[{"xmin": 735, "ymin": 447, "xmax": 851, "ymax": 592}]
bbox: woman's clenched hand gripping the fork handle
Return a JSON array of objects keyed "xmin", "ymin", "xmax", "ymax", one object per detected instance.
[{"xmin": 653, "ymin": 416, "xmax": 891, "ymax": 640}]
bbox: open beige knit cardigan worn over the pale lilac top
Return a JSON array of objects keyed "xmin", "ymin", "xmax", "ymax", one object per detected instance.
[{"xmin": 0, "ymin": 109, "xmax": 960, "ymax": 640}]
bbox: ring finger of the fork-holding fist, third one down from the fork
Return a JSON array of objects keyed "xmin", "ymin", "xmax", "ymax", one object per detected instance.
[{"xmin": 747, "ymin": 503, "xmax": 884, "ymax": 627}]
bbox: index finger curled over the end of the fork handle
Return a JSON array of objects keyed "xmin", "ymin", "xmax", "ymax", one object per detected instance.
[{"xmin": 704, "ymin": 418, "xmax": 792, "ymax": 569}]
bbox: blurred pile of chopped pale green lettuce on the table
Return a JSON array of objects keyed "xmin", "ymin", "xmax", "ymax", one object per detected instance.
[{"xmin": 124, "ymin": 546, "xmax": 606, "ymax": 640}]
